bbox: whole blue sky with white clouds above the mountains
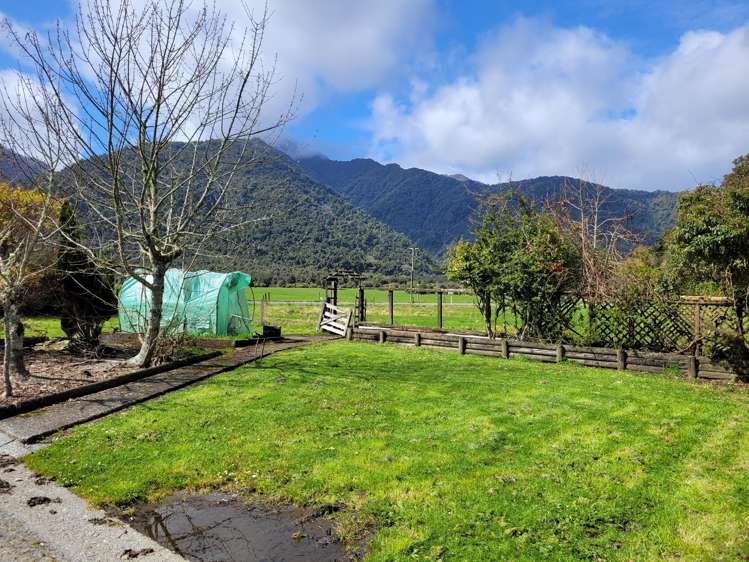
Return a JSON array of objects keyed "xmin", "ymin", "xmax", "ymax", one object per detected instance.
[{"xmin": 0, "ymin": 0, "xmax": 749, "ymax": 190}]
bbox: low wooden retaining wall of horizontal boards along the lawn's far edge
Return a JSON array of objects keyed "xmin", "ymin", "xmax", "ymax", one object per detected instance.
[{"xmin": 348, "ymin": 324, "xmax": 736, "ymax": 381}]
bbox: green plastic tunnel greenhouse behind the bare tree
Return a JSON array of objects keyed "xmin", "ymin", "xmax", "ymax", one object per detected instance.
[{"xmin": 119, "ymin": 269, "xmax": 252, "ymax": 336}]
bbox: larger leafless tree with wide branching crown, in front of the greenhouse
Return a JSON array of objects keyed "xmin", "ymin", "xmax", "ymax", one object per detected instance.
[{"xmin": 5, "ymin": 0, "xmax": 296, "ymax": 366}]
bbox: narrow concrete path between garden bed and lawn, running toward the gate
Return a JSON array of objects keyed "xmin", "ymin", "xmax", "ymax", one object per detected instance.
[{"xmin": 0, "ymin": 337, "xmax": 321, "ymax": 450}]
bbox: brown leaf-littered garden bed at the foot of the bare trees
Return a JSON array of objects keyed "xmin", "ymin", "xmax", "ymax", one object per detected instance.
[{"xmin": 0, "ymin": 346, "xmax": 135, "ymax": 407}]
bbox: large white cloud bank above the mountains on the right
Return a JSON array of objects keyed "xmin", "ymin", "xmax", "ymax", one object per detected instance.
[{"xmin": 371, "ymin": 19, "xmax": 749, "ymax": 189}]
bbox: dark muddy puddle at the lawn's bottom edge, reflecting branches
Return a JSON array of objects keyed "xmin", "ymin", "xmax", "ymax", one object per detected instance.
[{"xmin": 120, "ymin": 493, "xmax": 350, "ymax": 562}]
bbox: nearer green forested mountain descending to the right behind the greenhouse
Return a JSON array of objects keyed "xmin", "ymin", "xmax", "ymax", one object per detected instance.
[{"xmin": 60, "ymin": 141, "xmax": 436, "ymax": 284}]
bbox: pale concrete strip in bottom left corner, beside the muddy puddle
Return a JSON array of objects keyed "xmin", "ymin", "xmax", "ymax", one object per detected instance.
[{"xmin": 0, "ymin": 457, "xmax": 183, "ymax": 562}]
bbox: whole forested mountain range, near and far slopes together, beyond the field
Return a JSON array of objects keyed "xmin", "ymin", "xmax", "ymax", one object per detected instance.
[{"xmin": 5, "ymin": 135, "xmax": 678, "ymax": 283}]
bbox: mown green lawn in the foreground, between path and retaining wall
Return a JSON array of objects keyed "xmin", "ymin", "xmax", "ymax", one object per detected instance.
[{"xmin": 26, "ymin": 342, "xmax": 749, "ymax": 561}]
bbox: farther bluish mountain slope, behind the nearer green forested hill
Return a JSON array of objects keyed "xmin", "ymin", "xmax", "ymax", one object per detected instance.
[{"xmin": 298, "ymin": 156, "xmax": 678, "ymax": 254}]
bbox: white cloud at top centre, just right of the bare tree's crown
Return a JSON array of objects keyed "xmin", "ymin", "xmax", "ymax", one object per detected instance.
[{"xmin": 65, "ymin": 0, "xmax": 433, "ymax": 113}]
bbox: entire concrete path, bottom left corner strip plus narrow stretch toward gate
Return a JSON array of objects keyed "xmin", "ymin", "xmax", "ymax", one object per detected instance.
[{"xmin": 0, "ymin": 337, "xmax": 329, "ymax": 562}]
